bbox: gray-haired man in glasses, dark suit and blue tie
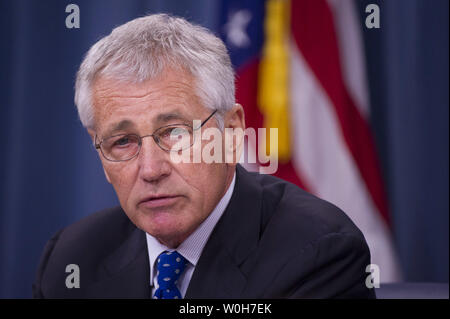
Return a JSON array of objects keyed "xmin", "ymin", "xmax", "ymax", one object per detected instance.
[{"xmin": 33, "ymin": 14, "xmax": 374, "ymax": 299}]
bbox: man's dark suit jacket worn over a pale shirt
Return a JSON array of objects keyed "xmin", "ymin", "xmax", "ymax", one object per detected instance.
[{"xmin": 33, "ymin": 165, "xmax": 375, "ymax": 298}]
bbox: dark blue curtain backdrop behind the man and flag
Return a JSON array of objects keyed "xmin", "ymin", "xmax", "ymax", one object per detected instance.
[{"xmin": 0, "ymin": 0, "xmax": 449, "ymax": 298}]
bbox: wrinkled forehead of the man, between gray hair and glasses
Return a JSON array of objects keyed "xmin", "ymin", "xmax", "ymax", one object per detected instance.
[{"xmin": 93, "ymin": 71, "xmax": 200, "ymax": 131}]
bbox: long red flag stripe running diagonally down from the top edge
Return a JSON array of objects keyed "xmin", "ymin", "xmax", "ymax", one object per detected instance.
[{"xmin": 291, "ymin": 0, "xmax": 389, "ymax": 224}]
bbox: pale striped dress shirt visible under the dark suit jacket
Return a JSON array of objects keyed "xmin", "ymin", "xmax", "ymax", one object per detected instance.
[{"xmin": 146, "ymin": 173, "xmax": 236, "ymax": 298}]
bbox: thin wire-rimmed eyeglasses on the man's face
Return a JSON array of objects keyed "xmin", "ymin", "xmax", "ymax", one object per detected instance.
[{"xmin": 94, "ymin": 110, "xmax": 217, "ymax": 162}]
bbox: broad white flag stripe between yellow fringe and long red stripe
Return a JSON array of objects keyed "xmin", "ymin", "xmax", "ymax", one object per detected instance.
[{"xmin": 290, "ymin": 41, "xmax": 399, "ymax": 282}]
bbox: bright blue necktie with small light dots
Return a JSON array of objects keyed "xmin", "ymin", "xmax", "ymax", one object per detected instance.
[{"xmin": 154, "ymin": 251, "xmax": 187, "ymax": 299}]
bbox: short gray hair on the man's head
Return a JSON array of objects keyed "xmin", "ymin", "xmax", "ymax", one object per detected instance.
[{"xmin": 75, "ymin": 14, "xmax": 235, "ymax": 129}]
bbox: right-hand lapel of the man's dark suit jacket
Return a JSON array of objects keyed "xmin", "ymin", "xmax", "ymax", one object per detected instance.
[{"xmin": 185, "ymin": 165, "xmax": 262, "ymax": 298}]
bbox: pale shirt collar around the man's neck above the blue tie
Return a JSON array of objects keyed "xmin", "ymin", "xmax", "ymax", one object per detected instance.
[{"xmin": 145, "ymin": 173, "xmax": 236, "ymax": 286}]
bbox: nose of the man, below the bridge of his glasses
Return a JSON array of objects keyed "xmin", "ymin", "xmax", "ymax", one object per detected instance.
[{"xmin": 138, "ymin": 136, "xmax": 171, "ymax": 183}]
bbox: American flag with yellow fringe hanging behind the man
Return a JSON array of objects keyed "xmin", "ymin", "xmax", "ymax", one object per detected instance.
[{"xmin": 220, "ymin": 0, "xmax": 401, "ymax": 282}]
